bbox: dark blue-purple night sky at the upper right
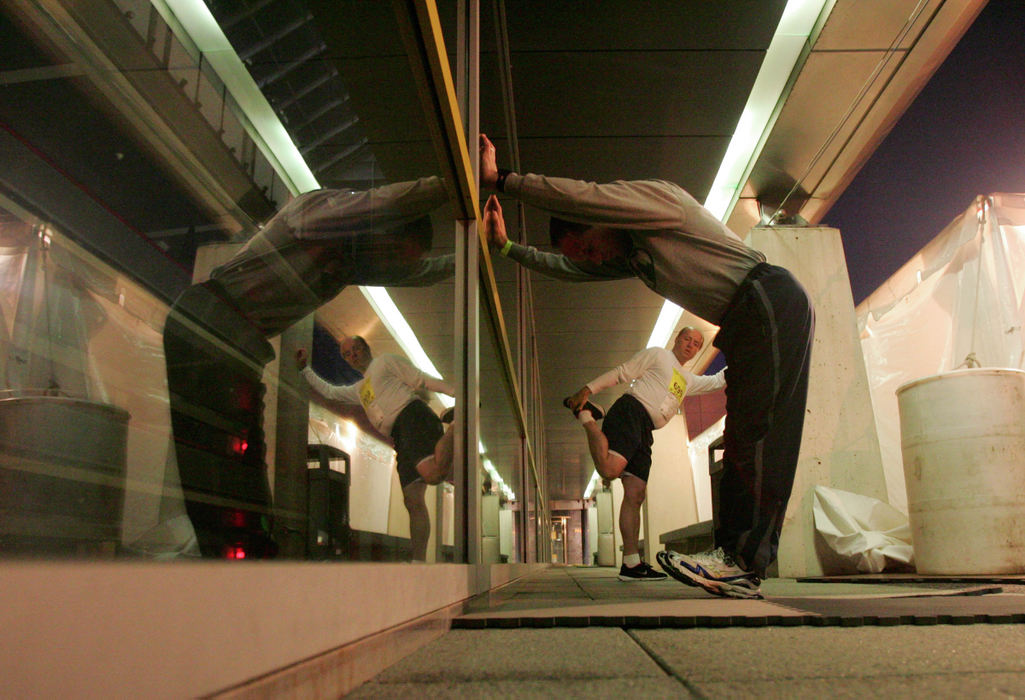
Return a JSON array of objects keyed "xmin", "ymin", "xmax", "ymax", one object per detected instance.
[{"xmin": 821, "ymin": 0, "xmax": 1025, "ymax": 304}]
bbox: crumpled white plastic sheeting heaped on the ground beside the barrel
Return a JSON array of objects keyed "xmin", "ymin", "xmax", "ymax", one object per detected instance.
[{"xmin": 812, "ymin": 486, "xmax": 914, "ymax": 574}]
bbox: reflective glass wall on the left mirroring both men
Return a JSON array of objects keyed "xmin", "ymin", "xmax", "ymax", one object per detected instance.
[{"xmin": 0, "ymin": 0, "xmax": 537, "ymax": 563}]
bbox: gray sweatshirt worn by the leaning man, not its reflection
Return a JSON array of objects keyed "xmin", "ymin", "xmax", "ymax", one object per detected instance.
[{"xmin": 503, "ymin": 173, "xmax": 765, "ymax": 324}]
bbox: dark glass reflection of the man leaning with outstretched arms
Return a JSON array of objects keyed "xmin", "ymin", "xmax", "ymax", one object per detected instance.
[{"xmin": 164, "ymin": 177, "xmax": 453, "ymax": 558}]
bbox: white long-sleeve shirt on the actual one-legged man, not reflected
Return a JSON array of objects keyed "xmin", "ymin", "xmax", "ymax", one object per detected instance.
[{"xmin": 587, "ymin": 347, "xmax": 726, "ymax": 429}]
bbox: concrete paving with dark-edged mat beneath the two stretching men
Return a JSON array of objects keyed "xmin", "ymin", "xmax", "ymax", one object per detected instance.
[{"xmin": 350, "ymin": 567, "xmax": 1025, "ymax": 698}]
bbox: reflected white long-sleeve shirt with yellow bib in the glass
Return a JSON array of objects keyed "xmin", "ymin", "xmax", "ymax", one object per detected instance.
[{"xmin": 302, "ymin": 355, "xmax": 455, "ymax": 436}]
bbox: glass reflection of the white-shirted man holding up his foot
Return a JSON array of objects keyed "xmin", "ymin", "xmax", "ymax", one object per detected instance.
[{"xmin": 295, "ymin": 335, "xmax": 455, "ymax": 562}]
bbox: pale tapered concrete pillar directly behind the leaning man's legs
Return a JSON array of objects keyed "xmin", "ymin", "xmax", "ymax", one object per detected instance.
[{"xmin": 746, "ymin": 227, "xmax": 887, "ymax": 577}]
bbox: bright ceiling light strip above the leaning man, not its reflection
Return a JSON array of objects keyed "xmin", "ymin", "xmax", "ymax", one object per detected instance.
[{"xmin": 647, "ymin": 0, "xmax": 833, "ymax": 347}]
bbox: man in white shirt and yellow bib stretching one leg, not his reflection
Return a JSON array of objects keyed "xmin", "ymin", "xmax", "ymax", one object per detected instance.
[{"xmin": 566, "ymin": 326, "xmax": 726, "ymax": 581}]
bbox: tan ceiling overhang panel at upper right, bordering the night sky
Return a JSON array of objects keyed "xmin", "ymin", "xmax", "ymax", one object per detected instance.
[{"xmin": 727, "ymin": 0, "xmax": 985, "ymax": 234}]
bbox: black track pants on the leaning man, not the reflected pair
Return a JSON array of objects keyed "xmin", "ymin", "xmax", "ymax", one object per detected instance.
[{"xmin": 715, "ymin": 262, "xmax": 815, "ymax": 576}]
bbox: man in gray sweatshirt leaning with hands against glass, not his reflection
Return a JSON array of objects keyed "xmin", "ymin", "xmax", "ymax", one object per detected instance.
[{"xmin": 480, "ymin": 134, "xmax": 815, "ymax": 598}]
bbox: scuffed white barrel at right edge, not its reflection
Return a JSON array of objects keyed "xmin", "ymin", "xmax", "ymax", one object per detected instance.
[{"xmin": 897, "ymin": 368, "xmax": 1025, "ymax": 575}]
